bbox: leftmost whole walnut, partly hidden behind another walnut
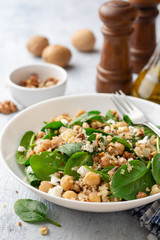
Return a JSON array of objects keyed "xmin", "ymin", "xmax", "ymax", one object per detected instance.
[{"xmin": 27, "ymin": 35, "xmax": 49, "ymax": 57}]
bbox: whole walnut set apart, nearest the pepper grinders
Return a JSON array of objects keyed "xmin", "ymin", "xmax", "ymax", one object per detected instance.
[{"xmin": 71, "ymin": 29, "xmax": 96, "ymax": 52}]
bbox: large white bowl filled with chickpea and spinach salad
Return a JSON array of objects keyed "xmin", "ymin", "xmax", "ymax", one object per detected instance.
[{"xmin": 0, "ymin": 94, "xmax": 160, "ymax": 212}]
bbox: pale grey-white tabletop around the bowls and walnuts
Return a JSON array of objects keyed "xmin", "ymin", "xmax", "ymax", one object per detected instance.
[{"xmin": 0, "ymin": 0, "xmax": 160, "ymax": 240}]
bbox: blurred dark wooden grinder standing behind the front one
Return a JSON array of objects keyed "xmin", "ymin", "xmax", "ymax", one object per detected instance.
[{"xmin": 129, "ymin": 0, "xmax": 160, "ymax": 73}]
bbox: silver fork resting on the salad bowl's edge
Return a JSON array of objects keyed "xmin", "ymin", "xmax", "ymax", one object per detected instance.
[{"xmin": 111, "ymin": 90, "xmax": 160, "ymax": 137}]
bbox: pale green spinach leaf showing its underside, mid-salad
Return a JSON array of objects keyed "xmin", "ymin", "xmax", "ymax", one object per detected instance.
[{"xmin": 56, "ymin": 143, "xmax": 84, "ymax": 157}]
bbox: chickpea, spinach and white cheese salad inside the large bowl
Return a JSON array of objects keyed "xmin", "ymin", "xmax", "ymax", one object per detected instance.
[{"xmin": 15, "ymin": 110, "xmax": 160, "ymax": 202}]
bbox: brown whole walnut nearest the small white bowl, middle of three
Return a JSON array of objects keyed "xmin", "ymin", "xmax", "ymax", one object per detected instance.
[{"xmin": 42, "ymin": 45, "xmax": 72, "ymax": 67}]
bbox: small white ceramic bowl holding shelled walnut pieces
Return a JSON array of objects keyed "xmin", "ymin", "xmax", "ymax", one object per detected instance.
[{"xmin": 8, "ymin": 63, "xmax": 67, "ymax": 107}]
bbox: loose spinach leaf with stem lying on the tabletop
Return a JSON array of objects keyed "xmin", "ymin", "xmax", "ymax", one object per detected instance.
[{"xmin": 14, "ymin": 199, "xmax": 61, "ymax": 227}]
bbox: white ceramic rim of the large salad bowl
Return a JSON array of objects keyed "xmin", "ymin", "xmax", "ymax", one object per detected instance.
[{"xmin": 0, "ymin": 93, "xmax": 160, "ymax": 212}]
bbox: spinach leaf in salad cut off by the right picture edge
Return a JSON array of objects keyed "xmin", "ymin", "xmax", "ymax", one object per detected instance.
[{"xmin": 152, "ymin": 153, "xmax": 160, "ymax": 184}]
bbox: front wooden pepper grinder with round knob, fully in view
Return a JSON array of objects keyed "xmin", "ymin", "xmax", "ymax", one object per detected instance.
[{"xmin": 96, "ymin": 1, "xmax": 137, "ymax": 94}]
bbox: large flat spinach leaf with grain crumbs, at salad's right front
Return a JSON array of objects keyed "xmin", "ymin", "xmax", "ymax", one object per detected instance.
[{"xmin": 111, "ymin": 160, "xmax": 155, "ymax": 200}]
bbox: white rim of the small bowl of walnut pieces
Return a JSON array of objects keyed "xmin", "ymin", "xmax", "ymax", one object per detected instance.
[{"xmin": 7, "ymin": 63, "xmax": 68, "ymax": 92}]
